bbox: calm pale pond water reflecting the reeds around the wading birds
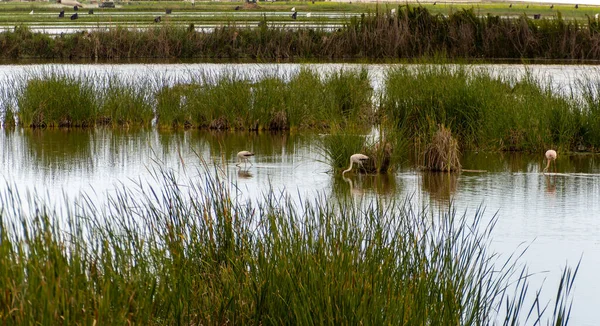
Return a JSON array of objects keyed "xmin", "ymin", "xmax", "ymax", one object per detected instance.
[{"xmin": 0, "ymin": 64, "xmax": 600, "ymax": 325}]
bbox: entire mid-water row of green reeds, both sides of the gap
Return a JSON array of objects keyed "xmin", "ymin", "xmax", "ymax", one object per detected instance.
[{"xmin": 9, "ymin": 65, "xmax": 600, "ymax": 154}]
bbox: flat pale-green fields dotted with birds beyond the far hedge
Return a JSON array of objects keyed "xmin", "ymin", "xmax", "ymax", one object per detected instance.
[{"xmin": 0, "ymin": 1, "xmax": 600, "ymax": 26}]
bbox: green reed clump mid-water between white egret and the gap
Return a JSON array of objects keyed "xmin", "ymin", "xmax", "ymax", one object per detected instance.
[{"xmin": 156, "ymin": 68, "xmax": 374, "ymax": 130}]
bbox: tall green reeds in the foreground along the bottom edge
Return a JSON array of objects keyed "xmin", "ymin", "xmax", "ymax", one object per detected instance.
[{"xmin": 0, "ymin": 167, "xmax": 577, "ymax": 325}]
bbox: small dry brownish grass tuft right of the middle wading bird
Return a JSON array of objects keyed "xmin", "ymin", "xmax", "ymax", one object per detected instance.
[{"xmin": 423, "ymin": 125, "xmax": 462, "ymax": 172}]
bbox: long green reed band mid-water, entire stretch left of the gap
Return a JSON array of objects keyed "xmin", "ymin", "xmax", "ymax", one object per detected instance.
[{"xmin": 13, "ymin": 69, "xmax": 374, "ymax": 130}]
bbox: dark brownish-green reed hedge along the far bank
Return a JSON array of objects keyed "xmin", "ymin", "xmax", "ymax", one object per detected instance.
[{"xmin": 0, "ymin": 6, "xmax": 600, "ymax": 60}]
